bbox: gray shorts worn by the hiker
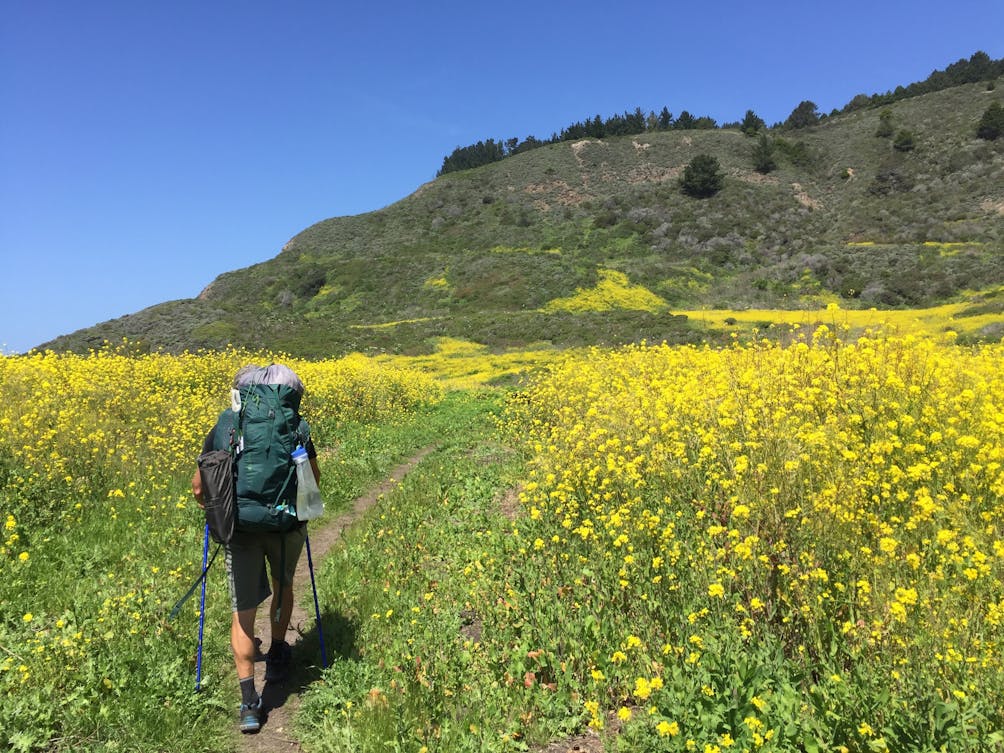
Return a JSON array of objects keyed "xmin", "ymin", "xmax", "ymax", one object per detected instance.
[{"xmin": 224, "ymin": 526, "xmax": 307, "ymax": 611}]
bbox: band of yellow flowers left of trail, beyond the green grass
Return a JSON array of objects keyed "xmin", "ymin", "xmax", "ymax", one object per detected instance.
[{"xmin": 0, "ymin": 343, "xmax": 441, "ymax": 534}]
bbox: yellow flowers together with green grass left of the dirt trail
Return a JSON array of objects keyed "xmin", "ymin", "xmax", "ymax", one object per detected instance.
[{"xmin": 0, "ymin": 347, "xmax": 442, "ymax": 752}]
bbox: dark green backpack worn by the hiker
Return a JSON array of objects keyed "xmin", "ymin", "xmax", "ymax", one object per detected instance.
[{"xmin": 213, "ymin": 385, "xmax": 310, "ymax": 531}]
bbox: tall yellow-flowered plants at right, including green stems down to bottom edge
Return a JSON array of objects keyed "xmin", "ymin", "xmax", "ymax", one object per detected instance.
[{"xmin": 510, "ymin": 326, "xmax": 1004, "ymax": 752}]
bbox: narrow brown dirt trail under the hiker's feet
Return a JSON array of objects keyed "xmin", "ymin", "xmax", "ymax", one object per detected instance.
[{"xmin": 235, "ymin": 447, "xmax": 435, "ymax": 753}]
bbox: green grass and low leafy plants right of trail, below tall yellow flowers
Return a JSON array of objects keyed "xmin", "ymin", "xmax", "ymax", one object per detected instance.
[{"xmin": 296, "ymin": 363, "xmax": 1004, "ymax": 753}]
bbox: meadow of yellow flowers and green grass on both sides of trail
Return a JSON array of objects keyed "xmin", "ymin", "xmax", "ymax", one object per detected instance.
[{"xmin": 0, "ymin": 333, "xmax": 1004, "ymax": 753}]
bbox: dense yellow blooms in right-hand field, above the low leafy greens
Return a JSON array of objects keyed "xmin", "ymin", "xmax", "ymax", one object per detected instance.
[{"xmin": 510, "ymin": 333, "xmax": 1004, "ymax": 697}]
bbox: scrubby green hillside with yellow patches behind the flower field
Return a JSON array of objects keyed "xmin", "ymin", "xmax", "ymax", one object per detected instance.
[{"xmin": 43, "ymin": 80, "xmax": 1004, "ymax": 356}]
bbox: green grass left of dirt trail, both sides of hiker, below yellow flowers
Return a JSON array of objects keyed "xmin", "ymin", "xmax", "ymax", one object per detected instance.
[{"xmin": 0, "ymin": 396, "xmax": 485, "ymax": 753}]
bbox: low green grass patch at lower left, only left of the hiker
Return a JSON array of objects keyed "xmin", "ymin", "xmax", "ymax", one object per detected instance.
[{"xmin": 0, "ymin": 473, "xmax": 226, "ymax": 751}]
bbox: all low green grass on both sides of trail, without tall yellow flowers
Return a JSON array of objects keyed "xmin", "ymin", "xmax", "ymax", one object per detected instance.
[{"xmin": 7, "ymin": 363, "xmax": 1002, "ymax": 753}]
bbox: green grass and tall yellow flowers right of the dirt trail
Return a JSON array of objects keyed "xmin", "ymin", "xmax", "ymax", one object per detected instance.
[{"xmin": 297, "ymin": 335, "xmax": 1004, "ymax": 753}]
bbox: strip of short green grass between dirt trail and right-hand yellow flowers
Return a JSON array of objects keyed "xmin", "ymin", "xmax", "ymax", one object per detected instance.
[{"xmin": 296, "ymin": 394, "xmax": 558, "ymax": 753}]
